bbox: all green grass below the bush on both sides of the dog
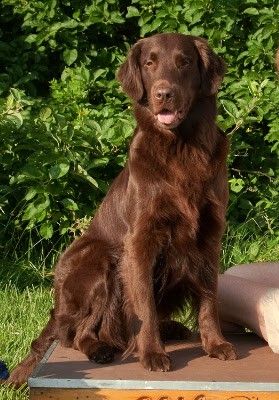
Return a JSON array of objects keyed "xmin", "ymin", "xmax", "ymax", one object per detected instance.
[{"xmin": 0, "ymin": 220, "xmax": 279, "ymax": 400}]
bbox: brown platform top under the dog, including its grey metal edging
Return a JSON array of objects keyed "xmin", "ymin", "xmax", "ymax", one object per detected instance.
[{"xmin": 29, "ymin": 335, "xmax": 279, "ymax": 392}]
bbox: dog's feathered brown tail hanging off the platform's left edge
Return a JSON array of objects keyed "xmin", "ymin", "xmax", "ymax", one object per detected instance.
[{"xmin": 6, "ymin": 310, "xmax": 57, "ymax": 388}]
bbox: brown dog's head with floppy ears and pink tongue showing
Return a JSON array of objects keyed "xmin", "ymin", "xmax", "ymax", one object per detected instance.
[{"xmin": 118, "ymin": 33, "xmax": 225, "ymax": 129}]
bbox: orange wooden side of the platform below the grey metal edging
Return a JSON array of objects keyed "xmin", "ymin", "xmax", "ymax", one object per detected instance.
[{"xmin": 30, "ymin": 389, "xmax": 279, "ymax": 400}]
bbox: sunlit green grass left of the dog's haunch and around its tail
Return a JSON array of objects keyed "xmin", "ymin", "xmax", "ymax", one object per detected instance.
[{"xmin": 0, "ymin": 283, "xmax": 52, "ymax": 400}]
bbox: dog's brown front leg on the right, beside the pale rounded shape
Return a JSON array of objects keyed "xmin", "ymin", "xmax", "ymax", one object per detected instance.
[{"xmin": 199, "ymin": 168, "xmax": 237, "ymax": 360}]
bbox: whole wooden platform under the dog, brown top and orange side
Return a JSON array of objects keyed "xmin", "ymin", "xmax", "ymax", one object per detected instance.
[{"xmin": 29, "ymin": 334, "xmax": 279, "ymax": 400}]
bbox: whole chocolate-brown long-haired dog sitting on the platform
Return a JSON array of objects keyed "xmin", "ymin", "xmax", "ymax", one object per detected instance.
[{"xmin": 10, "ymin": 34, "xmax": 236, "ymax": 385}]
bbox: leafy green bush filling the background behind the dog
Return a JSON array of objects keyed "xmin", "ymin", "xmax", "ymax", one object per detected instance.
[{"xmin": 0, "ymin": 0, "xmax": 279, "ymax": 255}]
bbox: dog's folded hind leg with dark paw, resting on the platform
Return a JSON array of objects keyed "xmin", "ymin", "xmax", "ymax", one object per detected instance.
[{"xmin": 57, "ymin": 237, "xmax": 119, "ymax": 363}]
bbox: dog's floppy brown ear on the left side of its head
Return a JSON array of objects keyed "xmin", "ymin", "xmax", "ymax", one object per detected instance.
[{"xmin": 117, "ymin": 40, "xmax": 144, "ymax": 101}]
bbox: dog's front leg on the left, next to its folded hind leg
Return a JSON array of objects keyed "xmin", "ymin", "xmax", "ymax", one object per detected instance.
[{"xmin": 122, "ymin": 232, "xmax": 170, "ymax": 371}]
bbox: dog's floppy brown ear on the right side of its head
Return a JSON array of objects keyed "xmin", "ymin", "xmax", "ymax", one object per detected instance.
[{"xmin": 194, "ymin": 37, "xmax": 226, "ymax": 96}]
